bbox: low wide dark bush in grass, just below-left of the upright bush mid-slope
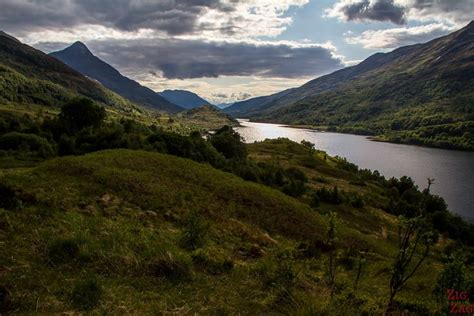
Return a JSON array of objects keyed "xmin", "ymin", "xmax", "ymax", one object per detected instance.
[{"xmin": 150, "ymin": 252, "xmax": 191, "ymax": 281}]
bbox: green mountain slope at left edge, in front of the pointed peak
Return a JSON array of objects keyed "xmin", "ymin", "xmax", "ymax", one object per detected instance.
[{"xmin": 0, "ymin": 32, "xmax": 140, "ymax": 112}]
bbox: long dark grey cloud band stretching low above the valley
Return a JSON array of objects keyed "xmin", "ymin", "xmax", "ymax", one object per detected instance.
[{"xmin": 83, "ymin": 39, "xmax": 343, "ymax": 79}]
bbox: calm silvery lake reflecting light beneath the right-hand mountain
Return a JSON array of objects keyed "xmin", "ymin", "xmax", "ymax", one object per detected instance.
[{"xmin": 236, "ymin": 120, "xmax": 474, "ymax": 221}]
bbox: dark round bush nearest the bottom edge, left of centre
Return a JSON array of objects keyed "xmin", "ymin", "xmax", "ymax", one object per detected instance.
[{"xmin": 71, "ymin": 277, "xmax": 102, "ymax": 310}]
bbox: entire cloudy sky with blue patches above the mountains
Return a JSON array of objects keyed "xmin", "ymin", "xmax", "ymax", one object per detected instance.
[{"xmin": 0, "ymin": 0, "xmax": 474, "ymax": 103}]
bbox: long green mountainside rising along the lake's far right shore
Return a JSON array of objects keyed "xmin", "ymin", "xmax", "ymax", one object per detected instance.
[{"xmin": 226, "ymin": 22, "xmax": 474, "ymax": 150}]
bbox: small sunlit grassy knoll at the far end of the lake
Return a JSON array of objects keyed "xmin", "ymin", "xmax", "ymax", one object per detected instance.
[{"xmin": 178, "ymin": 105, "xmax": 239, "ymax": 130}]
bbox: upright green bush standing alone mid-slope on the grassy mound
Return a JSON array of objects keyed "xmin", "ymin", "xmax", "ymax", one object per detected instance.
[{"xmin": 181, "ymin": 212, "xmax": 209, "ymax": 250}]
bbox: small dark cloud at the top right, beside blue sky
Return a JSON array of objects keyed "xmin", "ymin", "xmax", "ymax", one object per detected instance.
[{"xmin": 342, "ymin": 0, "xmax": 405, "ymax": 24}]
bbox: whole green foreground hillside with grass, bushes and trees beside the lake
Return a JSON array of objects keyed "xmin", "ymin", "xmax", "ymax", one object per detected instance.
[{"xmin": 0, "ymin": 99, "xmax": 474, "ymax": 315}]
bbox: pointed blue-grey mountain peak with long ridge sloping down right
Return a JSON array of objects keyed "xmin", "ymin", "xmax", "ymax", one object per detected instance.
[{"xmin": 50, "ymin": 42, "xmax": 183, "ymax": 113}]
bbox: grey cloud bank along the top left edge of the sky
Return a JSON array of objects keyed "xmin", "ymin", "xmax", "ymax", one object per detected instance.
[{"xmin": 0, "ymin": 0, "xmax": 238, "ymax": 35}]
